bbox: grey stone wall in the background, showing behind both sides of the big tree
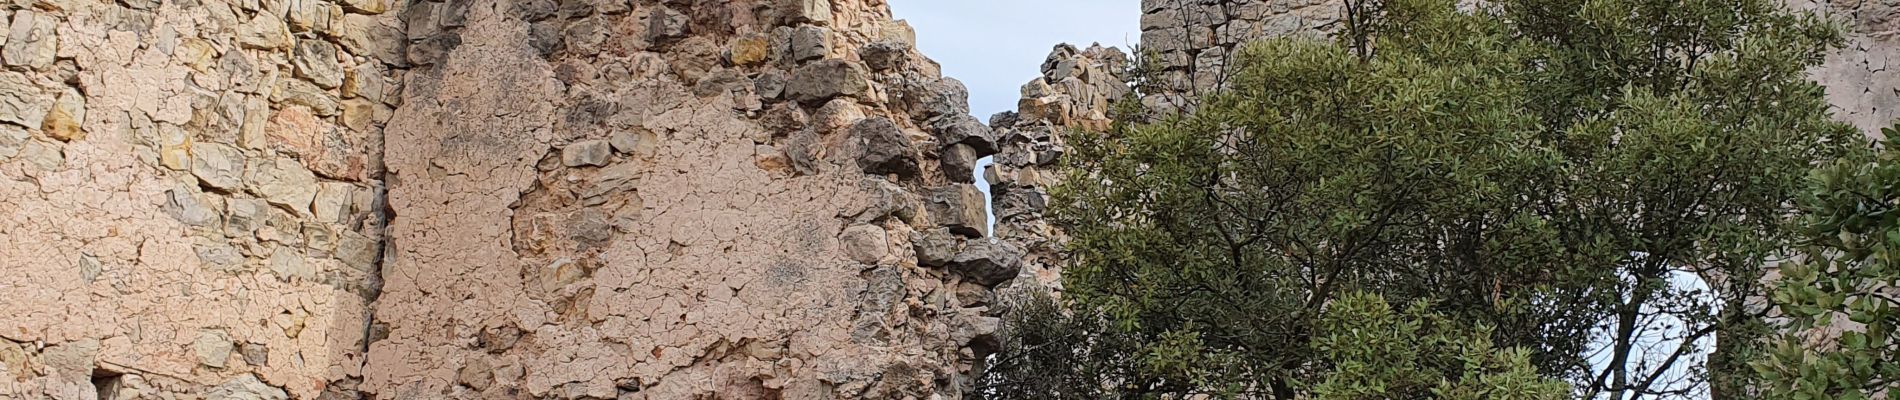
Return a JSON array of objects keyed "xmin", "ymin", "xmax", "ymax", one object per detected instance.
[{"xmin": 1142, "ymin": 0, "xmax": 1900, "ymax": 133}]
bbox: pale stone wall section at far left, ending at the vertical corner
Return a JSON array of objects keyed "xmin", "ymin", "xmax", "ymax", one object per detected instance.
[{"xmin": 0, "ymin": 0, "xmax": 409, "ymax": 400}]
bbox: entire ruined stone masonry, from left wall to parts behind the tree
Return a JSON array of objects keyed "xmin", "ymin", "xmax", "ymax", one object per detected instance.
[{"xmin": 0, "ymin": 0, "xmax": 1900, "ymax": 400}]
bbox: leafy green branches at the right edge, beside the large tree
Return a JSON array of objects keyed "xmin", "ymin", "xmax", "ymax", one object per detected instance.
[{"xmin": 1756, "ymin": 125, "xmax": 1900, "ymax": 400}]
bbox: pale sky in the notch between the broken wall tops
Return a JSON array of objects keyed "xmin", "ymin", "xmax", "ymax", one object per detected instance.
[{"xmin": 891, "ymin": 0, "xmax": 1142, "ymax": 121}]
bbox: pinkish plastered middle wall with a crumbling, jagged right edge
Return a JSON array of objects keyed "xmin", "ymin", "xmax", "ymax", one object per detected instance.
[{"xmin": 361, "ymin": 0, "xmax": 1017, "ymax": 398}]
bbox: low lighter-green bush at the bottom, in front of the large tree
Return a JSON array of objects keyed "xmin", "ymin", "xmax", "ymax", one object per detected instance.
[{"xmin": 1313, "ymin": 294, "xmax": 1569, "ymax": 400}]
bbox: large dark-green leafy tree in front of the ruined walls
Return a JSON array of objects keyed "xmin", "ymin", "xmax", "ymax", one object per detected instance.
[{"xmin": 1032, "ymin": 0, "xmax": 1862, "ymax": 398}]
